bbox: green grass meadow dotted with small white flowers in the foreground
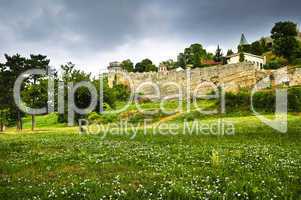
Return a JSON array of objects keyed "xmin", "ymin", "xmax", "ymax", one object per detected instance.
[{"xmin": 0, "ymin": 115, "xmax": 301, "ymax": 199}]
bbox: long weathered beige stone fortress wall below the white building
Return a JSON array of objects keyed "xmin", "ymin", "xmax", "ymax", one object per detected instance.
[{"xmin": 108, "ymin": 62, "xmax": 301, "ymax": 99}]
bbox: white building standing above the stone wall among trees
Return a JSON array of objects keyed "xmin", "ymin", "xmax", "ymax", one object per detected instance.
[{"xmin": 227, "ymin": 53, "xmax": 266, "ymax": 69}]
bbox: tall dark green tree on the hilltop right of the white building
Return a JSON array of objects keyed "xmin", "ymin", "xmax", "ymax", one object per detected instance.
[{"xmin": 271, "ymin": 21, "xmax": 299, "ymax": 61}]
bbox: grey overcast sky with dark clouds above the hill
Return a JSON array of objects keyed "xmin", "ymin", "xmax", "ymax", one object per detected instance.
[{"xmin": 0, "ymin": 0, "xmax": 301, "ymax": 72}]
